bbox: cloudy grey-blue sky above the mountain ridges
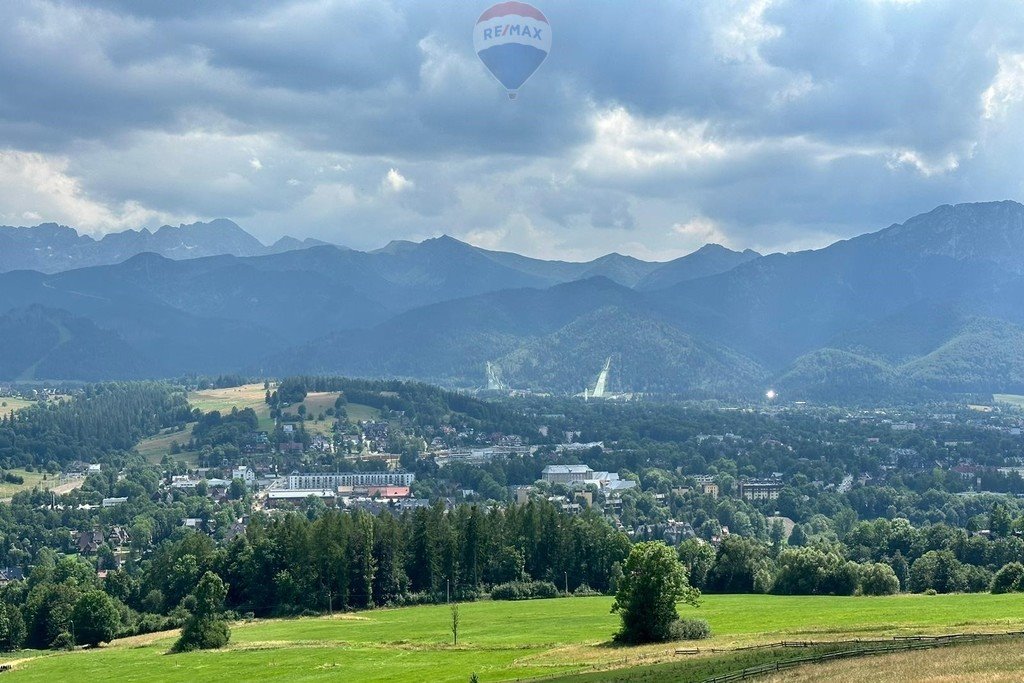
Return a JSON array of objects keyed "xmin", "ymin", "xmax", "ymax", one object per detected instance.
[{"xmin": 0, "ymin": 0, "xmax": 1024, "ymax": 259}]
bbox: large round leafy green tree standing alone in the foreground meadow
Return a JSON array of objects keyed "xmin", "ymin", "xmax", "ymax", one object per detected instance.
[{"xmin": 611, "ymin": 541, "xmax": 700, "ymax": 644}]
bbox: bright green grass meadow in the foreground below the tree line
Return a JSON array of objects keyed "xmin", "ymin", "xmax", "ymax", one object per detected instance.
[{"xmin": 4, "ymin": 594, "xmax": 1024, "ymax": 683}]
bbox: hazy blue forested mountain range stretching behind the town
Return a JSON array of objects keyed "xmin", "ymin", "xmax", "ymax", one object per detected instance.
[{"xmin": 0, "ymin": 202, "xmax": 1024, "ymax": 400}]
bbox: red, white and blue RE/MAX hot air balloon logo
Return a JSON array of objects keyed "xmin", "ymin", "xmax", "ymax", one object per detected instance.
[{"xmin": 473, "ymin": 2, "xmax": 551, "ymax": 99}]
